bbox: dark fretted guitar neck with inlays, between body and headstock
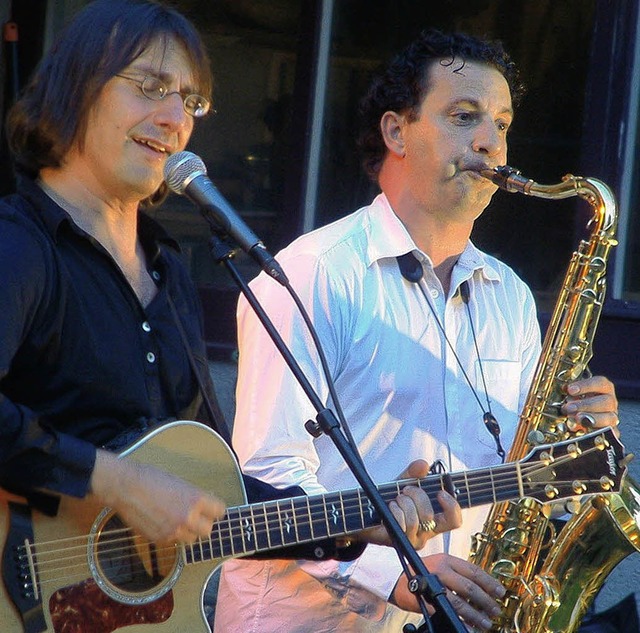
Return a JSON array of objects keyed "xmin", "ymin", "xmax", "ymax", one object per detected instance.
[{"xmin": 185, "ymin": 463, "xmax": 523, "ymax": 563}]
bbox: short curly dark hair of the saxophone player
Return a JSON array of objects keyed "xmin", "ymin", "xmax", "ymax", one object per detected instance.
[{"xmin": 358, "ymin": 29, "xmax": 523, "ymax": 182}]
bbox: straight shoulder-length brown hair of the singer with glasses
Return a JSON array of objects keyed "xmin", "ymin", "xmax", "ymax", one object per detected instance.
[{"xmin": 7, "ymin": 0, "xmax": 213, "ymax": 207}]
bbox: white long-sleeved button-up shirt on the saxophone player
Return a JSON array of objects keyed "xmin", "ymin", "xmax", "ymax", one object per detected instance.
[{"xmin": 215, "ymin": 194, "xmax": 540, "ymax": 633}]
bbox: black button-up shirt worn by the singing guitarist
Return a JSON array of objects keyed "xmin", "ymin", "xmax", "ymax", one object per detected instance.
[{"xmin": 0, "ymin": 179, "xmax": 208, "ymax": 496}]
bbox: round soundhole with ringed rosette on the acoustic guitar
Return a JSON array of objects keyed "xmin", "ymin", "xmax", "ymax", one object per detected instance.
[{"xmin": 90, "ymin": 512, "xmax": 181, "ymax": 604}]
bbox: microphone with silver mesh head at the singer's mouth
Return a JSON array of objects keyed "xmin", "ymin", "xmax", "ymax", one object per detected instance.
[{"xmin": 164, "ymin": 152, "xmax": 289, "ymax": 286}]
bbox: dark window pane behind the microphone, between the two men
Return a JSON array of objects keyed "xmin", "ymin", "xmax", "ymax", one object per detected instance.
[{"xmin": 150, "ymin": 0, "xmax": 300, "ymax": 287}]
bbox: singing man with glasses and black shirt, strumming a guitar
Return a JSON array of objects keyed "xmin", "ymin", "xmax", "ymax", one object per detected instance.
[{"xmin": 0, "ymin": 0, "xmax": 459, "ymax": 630}]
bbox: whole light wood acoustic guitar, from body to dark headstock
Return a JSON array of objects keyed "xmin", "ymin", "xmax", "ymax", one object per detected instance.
[{"xmin": 0, "ymin": 421, "xmax": 626, "ymax": 633}]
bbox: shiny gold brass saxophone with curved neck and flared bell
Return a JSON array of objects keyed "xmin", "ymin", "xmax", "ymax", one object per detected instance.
[{"xmin": 470, "ymin": 166, "xmax": 640, "ymax": 633}]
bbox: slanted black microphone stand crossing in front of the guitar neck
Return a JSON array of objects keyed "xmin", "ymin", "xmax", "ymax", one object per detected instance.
[{"xmin": 204, "ymin": 227, "xmax": 467, "ymax": 633}]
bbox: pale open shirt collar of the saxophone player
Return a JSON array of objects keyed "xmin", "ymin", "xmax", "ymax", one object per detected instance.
[{"xmin": 367, "ymin": 193, "xmax": 502, "ymax": 281}]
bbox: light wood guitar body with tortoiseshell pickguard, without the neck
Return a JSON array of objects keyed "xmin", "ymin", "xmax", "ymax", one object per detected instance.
[{"xmin": 0, "ymin": 421, "xmax": 246, "ymax": 633}]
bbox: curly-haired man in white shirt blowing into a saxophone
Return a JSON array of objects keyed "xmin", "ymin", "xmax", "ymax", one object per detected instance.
[{"xmin": 216, "ymin": 31, "xmax": 618, "ymax": 633}]
